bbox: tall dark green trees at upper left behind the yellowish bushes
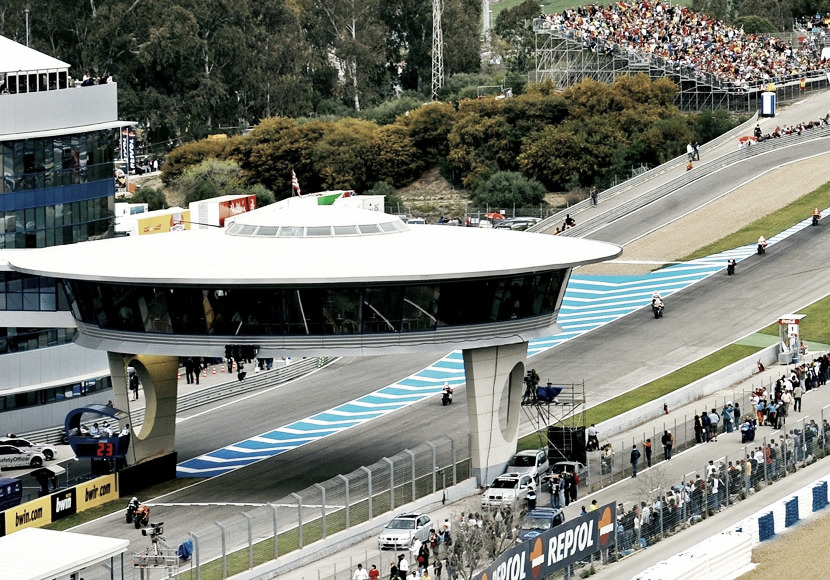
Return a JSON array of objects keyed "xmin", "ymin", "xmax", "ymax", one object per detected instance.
[{"xmin": 0, "ymin": 0, "xmax": 481, "ymax": 145}]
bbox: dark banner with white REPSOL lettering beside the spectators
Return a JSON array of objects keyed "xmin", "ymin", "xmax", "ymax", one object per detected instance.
[{"xmin": 473, "ymin": 503, "xmax": 617, "ymax": 580}]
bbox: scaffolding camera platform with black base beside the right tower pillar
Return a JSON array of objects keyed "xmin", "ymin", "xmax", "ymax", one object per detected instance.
[{"xmin": 522, "ymin": 381, "xmax": 586, "ymax": 463}]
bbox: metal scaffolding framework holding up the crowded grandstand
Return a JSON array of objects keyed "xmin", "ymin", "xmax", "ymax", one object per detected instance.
[{"xmin": 529, "ymin": 18, "xmax": 828, "ymax": 112}]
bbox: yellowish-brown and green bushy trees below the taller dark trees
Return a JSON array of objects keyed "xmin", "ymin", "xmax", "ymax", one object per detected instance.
[{"xmin": 163, "ymin": 75, "xmax": 734, "ymax": 199}]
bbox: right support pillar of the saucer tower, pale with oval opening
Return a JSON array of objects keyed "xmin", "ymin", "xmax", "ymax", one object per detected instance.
[{"xmin": 463, "ymin": 342, "xmax": 527, "ymax": 486}]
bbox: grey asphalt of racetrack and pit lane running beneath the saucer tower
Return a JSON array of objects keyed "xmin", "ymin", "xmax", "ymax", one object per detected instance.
[{"xmin": 73, "ymin": 130, "xmax": 830, "ymax": 568}]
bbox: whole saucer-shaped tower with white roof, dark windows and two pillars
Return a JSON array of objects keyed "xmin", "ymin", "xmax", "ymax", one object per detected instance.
[{"xmin": 9, "ymin": 204, "xmax": 622, "ymax": 482}]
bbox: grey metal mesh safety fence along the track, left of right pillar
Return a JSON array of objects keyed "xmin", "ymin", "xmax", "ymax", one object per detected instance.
[{"xmin": 178, "ymin": 437, "xmax": 471, "ymax": 580}]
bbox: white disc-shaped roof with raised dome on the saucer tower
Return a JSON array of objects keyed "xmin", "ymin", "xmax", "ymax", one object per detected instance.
[{"xmin": 8, "ymin": 206, "xmax": 622, "ymax": 285}]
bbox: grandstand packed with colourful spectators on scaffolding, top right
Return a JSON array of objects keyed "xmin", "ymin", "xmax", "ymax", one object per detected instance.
[{"xmin": 531, "ymin": 2, "xmax": 828, "ymax": 112}]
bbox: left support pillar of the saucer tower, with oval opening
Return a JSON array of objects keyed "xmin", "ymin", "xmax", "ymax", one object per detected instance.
[{"xmin": 107, "ymin": 352, "xmax": 179, "ymax": 465}]
